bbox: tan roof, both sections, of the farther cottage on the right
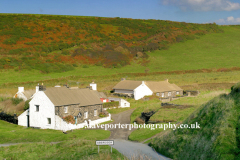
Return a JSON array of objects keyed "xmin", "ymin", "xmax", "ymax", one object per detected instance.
[{"xmin": 113, "ymin": 80, "xmax": 183, "ymax": 93}]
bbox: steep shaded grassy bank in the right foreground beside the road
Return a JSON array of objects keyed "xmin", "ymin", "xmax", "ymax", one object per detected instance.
[{"xmin": 151, "ymin": 84, "xmax": 240, "ymax": 160}]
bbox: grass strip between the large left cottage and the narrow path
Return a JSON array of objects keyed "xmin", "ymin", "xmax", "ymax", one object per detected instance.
[{"xmin": 0, "ymin": 120, "xmax": 110, "ymax": 143}]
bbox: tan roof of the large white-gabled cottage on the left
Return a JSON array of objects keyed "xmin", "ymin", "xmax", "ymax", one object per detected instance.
[{"xmin": 44, "ymin": 87, "xmax": 102, "ymax": 106}]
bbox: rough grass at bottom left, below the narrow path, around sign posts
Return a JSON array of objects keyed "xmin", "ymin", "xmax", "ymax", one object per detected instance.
[{"xmin": 0, "ymin": 139, "xmax": 126, "ymax": 160}]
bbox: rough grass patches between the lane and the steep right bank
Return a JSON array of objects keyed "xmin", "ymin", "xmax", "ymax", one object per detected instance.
[{"xmin": 129, "ymin": 90, "xmax": 230, "ymax": 142}]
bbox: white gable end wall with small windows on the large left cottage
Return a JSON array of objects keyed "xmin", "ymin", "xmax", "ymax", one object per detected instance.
[{"xmin": 29, "ymin": 91, "xmax": 55, "ymax": 129}]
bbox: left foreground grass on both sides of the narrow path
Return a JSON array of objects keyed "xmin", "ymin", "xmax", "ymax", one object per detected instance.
[{"xmin": 0, "ymin": 120, "xmax": 126, "ymax": 160}]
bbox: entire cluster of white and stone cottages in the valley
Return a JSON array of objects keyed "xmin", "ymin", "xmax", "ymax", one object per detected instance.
[{"xmin": 14, "ymin": 79, "xmax": 183, "ymax": 131}]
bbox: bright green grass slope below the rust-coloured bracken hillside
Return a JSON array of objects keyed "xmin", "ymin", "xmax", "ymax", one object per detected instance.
[{"xmin": 0, "ymin": 26, "xmax": 240, "ymax": 87}]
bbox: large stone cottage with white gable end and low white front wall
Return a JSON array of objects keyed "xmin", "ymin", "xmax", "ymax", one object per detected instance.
[{"xmin": 18, "ymin": 87, "xmax": 111, "ymax": 131}]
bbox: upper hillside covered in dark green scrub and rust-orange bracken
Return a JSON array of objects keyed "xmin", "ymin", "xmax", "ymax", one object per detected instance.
[{"xmin": 0, "ymin": 14, "xmax": 223, "ymax": 73}]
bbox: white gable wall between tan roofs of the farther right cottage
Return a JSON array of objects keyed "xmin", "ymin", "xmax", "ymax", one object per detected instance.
[{"xmin": 134, "ymin": 83, "xmax": 153, "ymax": 100}]
